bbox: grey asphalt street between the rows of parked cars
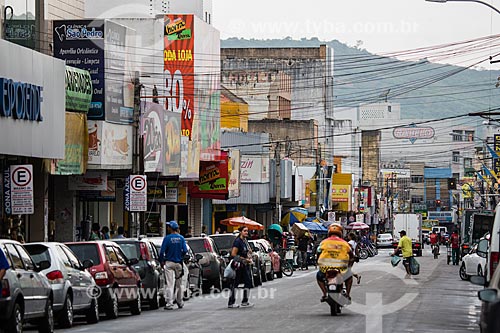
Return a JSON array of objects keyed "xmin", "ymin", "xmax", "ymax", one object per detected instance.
[{"xmin": 49, "ymin": 248, "xmax": 481, "ymax": 333}]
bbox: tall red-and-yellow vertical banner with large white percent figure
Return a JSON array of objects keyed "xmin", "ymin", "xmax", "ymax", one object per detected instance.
[{"xmin": 163, "ymin": 15, "xmax": 195, "ymax": 140}]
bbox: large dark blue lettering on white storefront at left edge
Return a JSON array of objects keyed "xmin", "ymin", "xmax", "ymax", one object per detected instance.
[{"xmin": 0, "ymin": 77, "xmax": 43, "ymax": 121}]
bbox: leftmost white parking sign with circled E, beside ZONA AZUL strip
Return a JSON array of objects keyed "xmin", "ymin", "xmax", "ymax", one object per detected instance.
[{"xmin": 10, "ymin": 164, "xmax": 34, "ymax": 215}]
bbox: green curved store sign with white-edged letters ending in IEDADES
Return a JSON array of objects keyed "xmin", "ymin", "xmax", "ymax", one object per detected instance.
[{"xmin": 65, "ymin": 66, "xmax": 92, "ymax": 112}]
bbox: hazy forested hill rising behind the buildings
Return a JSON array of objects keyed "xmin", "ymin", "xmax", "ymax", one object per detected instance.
[{"xmin": 221, "ymin": 38, "xmax": 500, "ymax": 122}]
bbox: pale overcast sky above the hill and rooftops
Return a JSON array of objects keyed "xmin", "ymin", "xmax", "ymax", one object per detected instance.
[{"xmin": 213, "ymin": 0, "xmax": 500, "ymax": 53}]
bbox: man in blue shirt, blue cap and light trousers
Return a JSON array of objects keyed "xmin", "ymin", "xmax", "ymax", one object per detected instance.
[{"xmin": 160, "ymin": 221, "xmax": 187, "ymax": 310}]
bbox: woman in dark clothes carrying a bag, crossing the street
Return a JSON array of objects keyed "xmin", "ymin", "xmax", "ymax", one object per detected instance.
[{"xmin": 227, "ymin": 226, "xmax": 253, "ymax": 309}]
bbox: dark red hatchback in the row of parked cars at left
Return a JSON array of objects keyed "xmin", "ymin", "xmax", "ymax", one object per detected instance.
[{"xmin": 66, "ymin": 241, "xmax": 142, "ymax": 319}]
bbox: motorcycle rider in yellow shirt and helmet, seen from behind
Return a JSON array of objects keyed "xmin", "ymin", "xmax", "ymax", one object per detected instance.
[{"xmin": 316, "ymin": 223, "xmax": 354, "ymax": 302}]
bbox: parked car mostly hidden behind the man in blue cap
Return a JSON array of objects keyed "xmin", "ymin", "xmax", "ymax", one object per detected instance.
[{"xmin": 148, "ymin": 237, "xmax": 203, "ymax": 300}]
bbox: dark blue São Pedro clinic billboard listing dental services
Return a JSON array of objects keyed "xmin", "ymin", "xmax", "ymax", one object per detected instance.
[{"xmin": 53, "ymin": 19, "xmax": 134, "ymax": 123}]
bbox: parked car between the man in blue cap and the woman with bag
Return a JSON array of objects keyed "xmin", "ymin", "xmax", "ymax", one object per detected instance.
[{"xmin": 186, "ymin": 237, "xmax": 226, "ymax": 293}]
